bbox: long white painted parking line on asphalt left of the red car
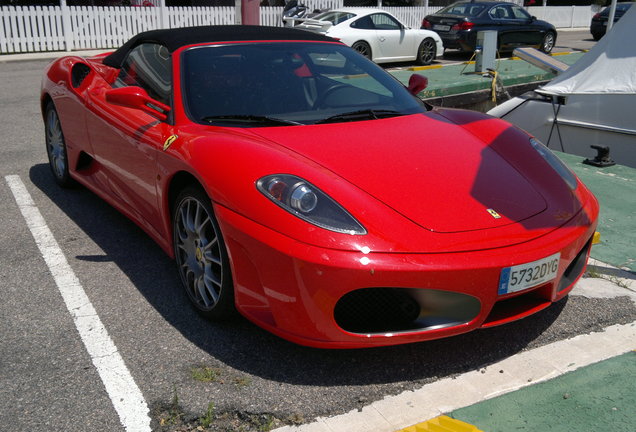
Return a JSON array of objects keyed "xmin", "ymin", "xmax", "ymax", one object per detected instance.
[{"xmin": 5, "ymin": 175, "xmax": 151, "ymax": 432}]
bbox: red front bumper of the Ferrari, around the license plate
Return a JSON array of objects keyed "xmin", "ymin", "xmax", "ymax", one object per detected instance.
[{"xmin": 215, "ymin": 206, "xmax": 598, "ymax": 348}]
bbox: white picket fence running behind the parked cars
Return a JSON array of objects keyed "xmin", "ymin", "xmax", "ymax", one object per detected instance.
[{"xmin": 0, "ymin": 4, "xmax": 592, "ymax": 55}]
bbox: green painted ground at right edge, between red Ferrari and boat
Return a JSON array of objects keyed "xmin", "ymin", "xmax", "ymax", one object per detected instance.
[{"xmin": 555, "ymin": 152, "xmax": 636, "ymax": 270}]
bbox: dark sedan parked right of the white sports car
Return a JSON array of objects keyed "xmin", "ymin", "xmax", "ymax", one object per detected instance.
[{"xmin": 422, "ymin": 1, "xmax": 557, "ymax": 53}]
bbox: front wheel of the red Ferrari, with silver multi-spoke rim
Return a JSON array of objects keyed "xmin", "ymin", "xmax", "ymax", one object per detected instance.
[{"xmin": 172, "ymin": 186, "xmax": 235, "ymax": 321}]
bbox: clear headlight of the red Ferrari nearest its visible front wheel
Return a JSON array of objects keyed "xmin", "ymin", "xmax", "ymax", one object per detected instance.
[{"xmin": 256, "ymin": 174, "xmax": 367, "ymax": 235}]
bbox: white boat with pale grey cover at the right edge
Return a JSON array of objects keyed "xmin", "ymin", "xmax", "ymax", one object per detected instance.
[{"xmin": 489, "ymin": 7, "xmax": 636, "ymax": 168}]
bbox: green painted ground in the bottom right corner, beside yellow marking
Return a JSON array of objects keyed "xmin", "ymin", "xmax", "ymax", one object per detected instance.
[{"xmin": 450, "ymin": 351, "xmax": 636, "ymax": 432}]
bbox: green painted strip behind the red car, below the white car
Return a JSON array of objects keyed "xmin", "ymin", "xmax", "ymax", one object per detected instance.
[{"xmin": 390, "ymin": 53, "xmax": 584, "ymax": 99}]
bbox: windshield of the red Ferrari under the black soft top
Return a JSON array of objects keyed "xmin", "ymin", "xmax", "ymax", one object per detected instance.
[{"xmin": 182, "ymin": 42, "xmax": 426, "ymax": 127}]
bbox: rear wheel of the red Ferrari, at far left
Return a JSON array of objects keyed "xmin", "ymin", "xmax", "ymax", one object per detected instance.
[{"xmin": 44, "ymin": 101, "xmax": 75, "ymax": 187}]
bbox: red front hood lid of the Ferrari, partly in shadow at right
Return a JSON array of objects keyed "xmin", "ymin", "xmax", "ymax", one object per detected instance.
[{"xmin": 252, "ymin": 111, "xmax": 547, "ymax": 233}]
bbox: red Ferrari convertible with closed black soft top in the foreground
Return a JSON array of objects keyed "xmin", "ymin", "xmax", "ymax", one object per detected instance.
[{"xmin": 41, "ymin": 26, "xmax": 598, "ymax": 348}]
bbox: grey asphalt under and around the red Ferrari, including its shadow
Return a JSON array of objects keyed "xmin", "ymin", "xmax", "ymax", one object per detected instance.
[{"xmin": 0, "ymin": 31, "xmax": 636, "ymax": 432}]
